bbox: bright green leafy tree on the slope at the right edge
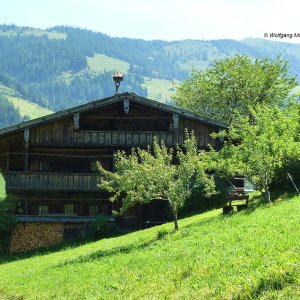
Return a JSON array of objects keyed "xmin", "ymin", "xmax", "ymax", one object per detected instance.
[{"xmin": 212, "ymin": 104, "xmax": 300, "ymax": 202}]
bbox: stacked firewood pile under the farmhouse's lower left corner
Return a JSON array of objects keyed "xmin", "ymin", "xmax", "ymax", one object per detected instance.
[{"xmin": 10, "ymin": 223, "xmax": 64, "ymax": 253}]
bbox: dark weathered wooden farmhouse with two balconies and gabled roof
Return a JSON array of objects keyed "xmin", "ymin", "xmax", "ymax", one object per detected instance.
[{"xmin": 0, "ymin": 93, "xmax": 225, "ymax": 251}]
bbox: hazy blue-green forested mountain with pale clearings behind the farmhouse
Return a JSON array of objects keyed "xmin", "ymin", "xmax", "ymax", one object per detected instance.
[{"xmin": 0, "ymin": 25, "xmax": 300, "ymax": 125}]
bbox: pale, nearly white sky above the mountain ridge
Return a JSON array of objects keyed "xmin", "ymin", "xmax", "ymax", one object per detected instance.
[{"xmin": 0, "ymin": 0, "xmax": 300, "ymax": 43}]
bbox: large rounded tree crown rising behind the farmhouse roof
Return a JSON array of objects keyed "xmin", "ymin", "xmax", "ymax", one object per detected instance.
[{"xmin": 173, "ymin": 55, "xmax": 297, "ymax": 124}]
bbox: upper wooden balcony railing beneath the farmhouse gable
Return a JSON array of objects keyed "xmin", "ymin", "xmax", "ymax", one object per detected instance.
[{"xmin": 31, "ymin": 131, "xmax": 177, "ymax": 147}]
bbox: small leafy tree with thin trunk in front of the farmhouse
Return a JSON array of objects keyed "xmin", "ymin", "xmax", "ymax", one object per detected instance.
[{"xmin": 98, "ymin": 136, "xmax": 214, "ymax": 230}]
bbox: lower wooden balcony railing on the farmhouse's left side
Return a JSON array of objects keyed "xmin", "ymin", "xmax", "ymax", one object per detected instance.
[{"xmin": 5, "ymin": 171, "xmax": 101, "ymax": 192}]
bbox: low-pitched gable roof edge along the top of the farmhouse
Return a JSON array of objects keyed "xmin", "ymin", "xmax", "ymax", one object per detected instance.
[{"xmin": 0, "ymin": 93, "xmax": 228, "ymax": 137}]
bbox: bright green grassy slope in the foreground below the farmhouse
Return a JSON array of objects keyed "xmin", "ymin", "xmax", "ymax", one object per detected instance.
[{"xmin": 0, "ymin": 197, "xmax": 300, "ymax": 299}]
